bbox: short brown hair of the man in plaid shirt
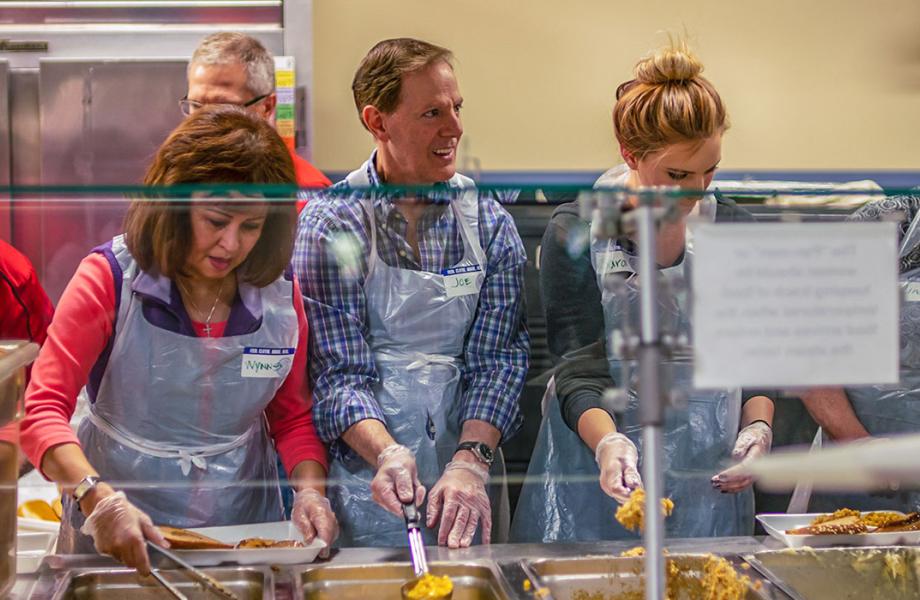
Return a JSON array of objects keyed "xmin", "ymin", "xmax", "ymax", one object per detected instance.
[{"xmin": 351, "ymin": 38, "xmax": 453, "ymax": 129}]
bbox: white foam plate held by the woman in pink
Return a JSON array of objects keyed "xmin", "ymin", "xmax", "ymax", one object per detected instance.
[{"xmin": 176, "ymin": 521, "xmax": 326, "ymax": 567}]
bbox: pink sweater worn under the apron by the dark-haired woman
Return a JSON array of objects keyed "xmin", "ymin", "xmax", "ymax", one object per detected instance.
[{"xmin": 21, "ymin": 254, "xmax": 328, "ymax": 473}]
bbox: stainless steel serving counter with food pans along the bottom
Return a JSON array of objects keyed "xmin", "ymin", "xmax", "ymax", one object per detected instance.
[{"xmin": 18, "ymin": 537, "xmax": 920, "ymax": 600}]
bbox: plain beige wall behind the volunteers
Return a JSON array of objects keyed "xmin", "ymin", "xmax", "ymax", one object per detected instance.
[{"xmin": 313, "ymin": 0, "xmax": 920, "ymax": 172}]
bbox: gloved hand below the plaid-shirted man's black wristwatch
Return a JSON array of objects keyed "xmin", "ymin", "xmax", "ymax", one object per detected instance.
[{"xmin": 426, "ymin": 460, "xmax": 492, "ymax": 548}]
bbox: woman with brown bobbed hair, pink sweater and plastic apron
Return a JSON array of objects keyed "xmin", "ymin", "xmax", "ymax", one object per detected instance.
[{"xmin": 22, "ymin": 106, "xmax": 337, "ymax": 573}]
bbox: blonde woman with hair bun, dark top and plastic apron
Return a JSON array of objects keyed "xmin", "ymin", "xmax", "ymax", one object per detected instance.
[{"xmin": 511, "ymin": 42, "xmax": 773, "ymax": 542}]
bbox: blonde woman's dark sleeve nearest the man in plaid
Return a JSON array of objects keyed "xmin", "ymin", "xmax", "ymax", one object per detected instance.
[{"xmin": 540, "ymin": 204, "xmax": 614, "ymax": 433}]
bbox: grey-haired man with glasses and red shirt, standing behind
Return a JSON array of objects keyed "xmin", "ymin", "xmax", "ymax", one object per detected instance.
[{"xmin": 180, "ymin": 32, "xmax": 331, "ymax": 199}]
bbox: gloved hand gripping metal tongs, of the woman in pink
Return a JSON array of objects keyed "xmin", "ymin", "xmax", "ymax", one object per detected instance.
[{"xmin": 80, "ymin": 492, "xmax": 169, "ymax": 575}]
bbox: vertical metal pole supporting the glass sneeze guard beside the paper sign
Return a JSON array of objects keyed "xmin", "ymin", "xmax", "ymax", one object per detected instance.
[{"xmin": 636, "ymin": 194, "xmax": 666, "ymax": 600}]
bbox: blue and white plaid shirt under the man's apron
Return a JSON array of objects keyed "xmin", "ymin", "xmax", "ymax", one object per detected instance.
[{"xmin": 294, "ymin": 154, "xmax": 530, "ymax": 454}]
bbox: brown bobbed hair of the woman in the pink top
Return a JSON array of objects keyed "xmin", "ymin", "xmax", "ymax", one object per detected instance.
[{"xmin": 125, "ymin": 105, "xmax": 297, "ymax": 287}]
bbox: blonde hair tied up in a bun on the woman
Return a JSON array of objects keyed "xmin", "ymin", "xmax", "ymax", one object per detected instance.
[{"xmin": 613, "ymin": 41, "xmax": 728, "ymax": 159}]
